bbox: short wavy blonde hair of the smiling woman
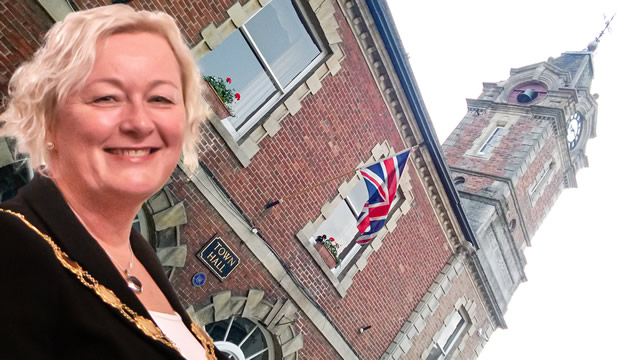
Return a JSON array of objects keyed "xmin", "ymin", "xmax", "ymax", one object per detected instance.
[{"xmin": 0, "ymin": 4, "xmax": 206, "ymax": 173}]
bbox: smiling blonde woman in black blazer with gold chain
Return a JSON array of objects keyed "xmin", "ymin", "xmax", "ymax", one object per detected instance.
[{"xmin": 0, "ymin": 5, "xmax": 224, "ymax": 360}]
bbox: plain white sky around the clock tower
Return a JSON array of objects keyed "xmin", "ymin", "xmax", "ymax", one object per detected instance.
[{"xmin": 387, "ymin": 0, "xmax": 640, "ymax": 360}]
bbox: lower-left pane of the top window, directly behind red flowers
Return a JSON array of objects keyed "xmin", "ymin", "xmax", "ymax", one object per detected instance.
[{"xmin": 200, "ymin": 30, "xmax": 276, "ymax": 130}]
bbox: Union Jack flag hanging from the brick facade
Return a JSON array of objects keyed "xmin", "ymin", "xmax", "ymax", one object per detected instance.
[{"xmin": 356, "ymin": 148, "xmax": 412, "ymax": 246}]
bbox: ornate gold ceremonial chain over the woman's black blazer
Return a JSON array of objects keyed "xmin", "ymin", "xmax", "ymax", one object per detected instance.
[{"xmin": 0, "ymin": 209, "xmax": 217, "ymax": 360}]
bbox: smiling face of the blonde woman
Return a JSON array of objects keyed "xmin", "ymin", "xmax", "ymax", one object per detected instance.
[{"xmin": 48, "ymin": 32, "xmax": 185, "ymax": 201}]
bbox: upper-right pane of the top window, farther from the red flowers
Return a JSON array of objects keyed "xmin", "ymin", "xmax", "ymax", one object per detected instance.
[{"xmin": 246, "ymin": 0, "xmax": 320, "ymax": 88}]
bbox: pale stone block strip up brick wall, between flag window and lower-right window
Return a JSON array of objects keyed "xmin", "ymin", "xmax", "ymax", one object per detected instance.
[{"xmin": 381, "ymin": 255, "xmax": 464, "ymax": 360}]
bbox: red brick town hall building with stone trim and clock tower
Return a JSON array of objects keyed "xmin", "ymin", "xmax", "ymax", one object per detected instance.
[{"xmin": 0, "ymin": 0, "xmax": 597, "ymax": 360}]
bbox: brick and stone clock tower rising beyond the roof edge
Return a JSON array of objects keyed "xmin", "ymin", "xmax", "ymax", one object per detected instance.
[{"xmin": 443, "ymin": 42, "xmax": 598, "ymax": 326}]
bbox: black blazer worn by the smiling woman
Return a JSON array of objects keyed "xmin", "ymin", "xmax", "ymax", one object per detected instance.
[{"xmin": 0, "ymin": 176, "xmax": 226, "ymax": 360}]
